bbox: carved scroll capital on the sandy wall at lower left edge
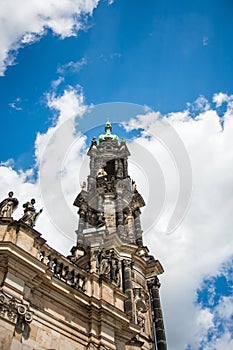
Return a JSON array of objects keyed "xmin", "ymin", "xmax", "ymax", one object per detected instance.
[{"xmin": 0, "ymin": 292, "xmax": 33, "ymax": 323}]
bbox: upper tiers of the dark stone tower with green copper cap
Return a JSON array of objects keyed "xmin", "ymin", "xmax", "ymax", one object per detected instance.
[{"xmin": 74, "ymin": 121, "xmax": 145, "ymax": 246}]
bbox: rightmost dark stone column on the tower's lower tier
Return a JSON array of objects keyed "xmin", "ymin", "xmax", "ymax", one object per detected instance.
[{"xmin": 147, "ymin": 276, "xmax": 167, "ymax": 350}]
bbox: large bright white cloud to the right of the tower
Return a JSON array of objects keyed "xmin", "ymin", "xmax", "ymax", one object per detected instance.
[{"xmin": 123, "ymin": 99, "xmax": 233, "ymax": 350}]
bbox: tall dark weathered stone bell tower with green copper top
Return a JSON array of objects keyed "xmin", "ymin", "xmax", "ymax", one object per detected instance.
[{"xmin": 73, "ymin": 122, "xmax": 167, "ymax": 350}]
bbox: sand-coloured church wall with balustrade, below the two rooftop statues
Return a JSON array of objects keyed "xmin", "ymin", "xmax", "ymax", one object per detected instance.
[{"xmin": 0, "ymin": 219, "xmax": 144, "ymax": 350}]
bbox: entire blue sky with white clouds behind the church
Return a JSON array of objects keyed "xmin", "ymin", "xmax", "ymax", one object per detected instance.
[{"xmin": 0, "ymin": 0, "xmax": 233, "ymax": 350}]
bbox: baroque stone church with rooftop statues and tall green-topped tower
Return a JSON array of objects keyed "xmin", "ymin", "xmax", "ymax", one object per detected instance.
[{"xmin": 0, "ymin": 122, "xmax": 167, "ymax": 350}]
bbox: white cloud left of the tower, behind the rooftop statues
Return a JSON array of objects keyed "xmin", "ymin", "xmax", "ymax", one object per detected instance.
[{"xmin": 0, "ymin": 88, "xmax": 86, "ymax": 254}]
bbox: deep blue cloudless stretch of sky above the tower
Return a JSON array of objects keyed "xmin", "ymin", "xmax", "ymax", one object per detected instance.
[{"xmin": 0, "ymin": 0, "xmax": 233, "ymax": 166}]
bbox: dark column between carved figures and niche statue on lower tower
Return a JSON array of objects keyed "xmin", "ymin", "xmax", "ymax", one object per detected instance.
[{"xmin": 123, "ymin": 260, "xmax": 134, "ymax": 322}]
